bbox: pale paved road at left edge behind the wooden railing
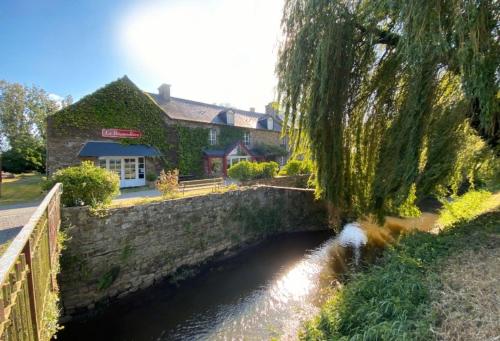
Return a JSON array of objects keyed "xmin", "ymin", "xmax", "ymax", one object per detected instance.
[{"xmin": 0, "ymin": 202, "xmax": 39, "ymax": 245}]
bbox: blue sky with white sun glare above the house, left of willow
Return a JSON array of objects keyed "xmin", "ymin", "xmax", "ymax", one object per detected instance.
[{"xmin": 0, "ymin": 0, "xmax": 284, "ymax": 111}]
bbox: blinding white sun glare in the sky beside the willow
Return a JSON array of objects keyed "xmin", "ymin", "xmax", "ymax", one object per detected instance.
[{"xmin": 119, "ymin": 0, "xmax": 283, "ymax": 110}]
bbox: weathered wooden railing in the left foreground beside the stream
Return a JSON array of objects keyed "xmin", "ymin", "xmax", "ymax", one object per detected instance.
[{"xmin": 0, "ymin": 184, "xmax": 62, "ymax": 341}]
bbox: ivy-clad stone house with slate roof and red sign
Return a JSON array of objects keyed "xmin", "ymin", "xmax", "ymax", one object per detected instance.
[{"xmin": 47, "ymin": 76, "xmax": 288, "ymax": 187}]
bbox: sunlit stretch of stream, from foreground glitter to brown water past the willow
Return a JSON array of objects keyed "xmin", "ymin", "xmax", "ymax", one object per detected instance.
[{"xmin": 166, "ymin": 213, "xmax": 436, "ymax": 340}]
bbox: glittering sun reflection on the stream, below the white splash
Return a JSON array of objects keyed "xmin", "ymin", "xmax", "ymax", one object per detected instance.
[{"xmin": 177, "ymin": 239, "xmax": 334, "ymax": 340}]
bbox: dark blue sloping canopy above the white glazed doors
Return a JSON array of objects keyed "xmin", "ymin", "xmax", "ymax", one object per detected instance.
[{"xmin": 78, "ymin": 142, "xmax": 160, "ymax": 157}]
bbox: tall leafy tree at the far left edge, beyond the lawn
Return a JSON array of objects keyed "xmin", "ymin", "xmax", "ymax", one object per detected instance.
[{"xmin": 0, "ymin": 80, "xmax": 59, "ymax": 172}]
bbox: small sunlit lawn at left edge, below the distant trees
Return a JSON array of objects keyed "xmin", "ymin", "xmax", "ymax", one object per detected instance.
[{"xmin": 0, "ymin": 173, "xmax": 45, "ymax": 206}]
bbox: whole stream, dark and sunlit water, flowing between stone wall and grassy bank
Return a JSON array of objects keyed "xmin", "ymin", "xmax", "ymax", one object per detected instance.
[{"xmin": 57, "ymin": 213, "xmax": 436, "ymax": 341}]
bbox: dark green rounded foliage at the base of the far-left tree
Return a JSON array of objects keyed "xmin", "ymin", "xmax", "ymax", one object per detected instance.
[{"xmin": 1, "ymin": 136, "xmax": 45, "ymax": 173}]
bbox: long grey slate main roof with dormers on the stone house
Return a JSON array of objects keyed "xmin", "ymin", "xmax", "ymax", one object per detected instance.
[{"xmin": 147, "ymin": 93, "xmax": 281, "ymax": 132}]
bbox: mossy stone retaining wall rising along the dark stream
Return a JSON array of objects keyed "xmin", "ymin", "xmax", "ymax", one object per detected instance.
[{"xmin": 59, "ymin": 186, "xmax": 327, "ymax": 317}]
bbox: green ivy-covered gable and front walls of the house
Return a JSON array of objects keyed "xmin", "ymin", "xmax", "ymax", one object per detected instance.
[{"xmin": 47, "ymin": 76, "xmax": 279, "ymax": 176}]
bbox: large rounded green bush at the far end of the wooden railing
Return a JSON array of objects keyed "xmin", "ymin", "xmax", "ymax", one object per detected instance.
[{"xmin": 44, "ymin": 161, "xmax": 120, "ymax": 207}]
